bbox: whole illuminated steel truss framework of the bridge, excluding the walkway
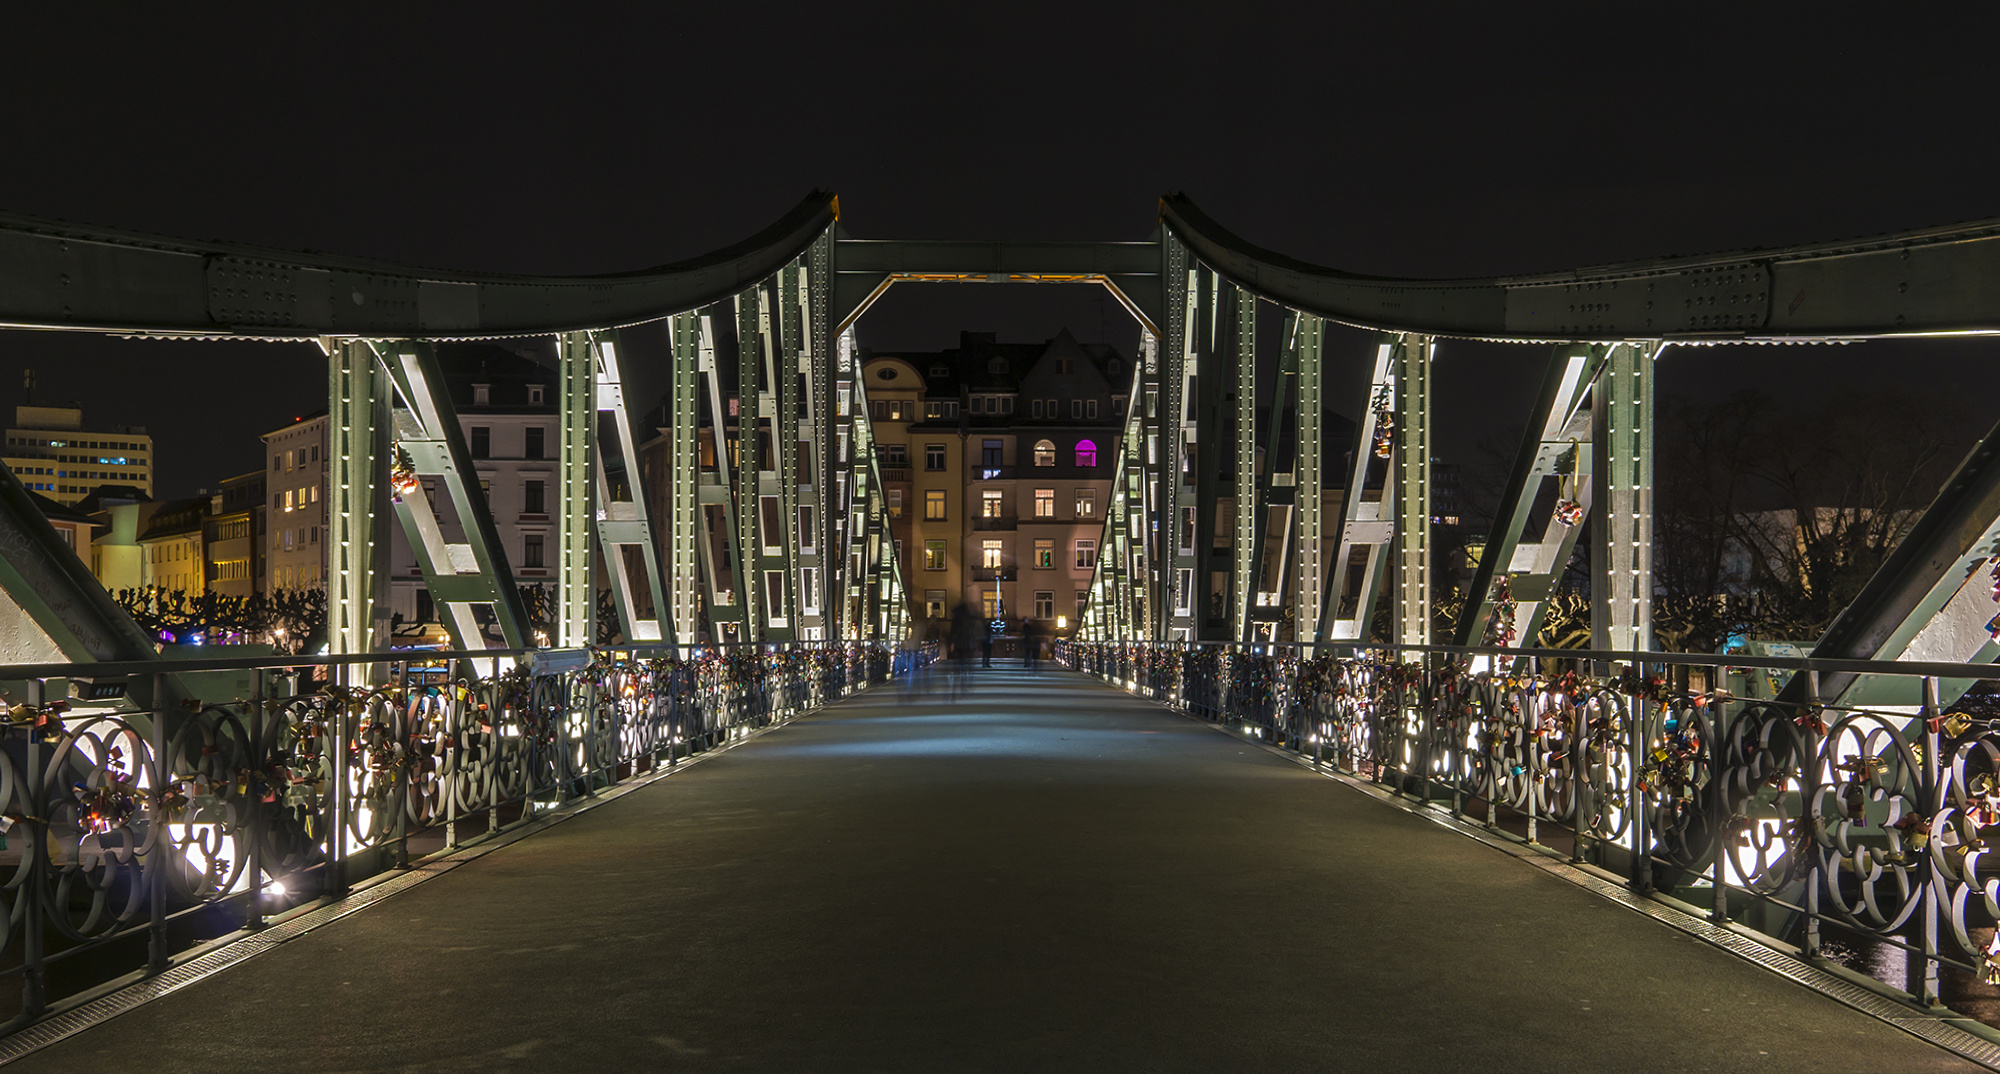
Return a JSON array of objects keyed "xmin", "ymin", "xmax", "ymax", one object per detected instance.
[{"xmin": 0, "ymin": 192, "xmax": 2000, "ymax": 1048}]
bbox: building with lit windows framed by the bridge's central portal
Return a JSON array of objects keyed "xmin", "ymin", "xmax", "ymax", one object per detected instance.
[{"xmin": 862, "ymin": 330, "xmax": 1132, "ymax": 632}]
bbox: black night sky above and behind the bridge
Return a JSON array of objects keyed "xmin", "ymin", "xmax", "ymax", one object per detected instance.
[{"xmin": 0, "ymin": 4, "xmax": 2000, "ymax": 496}]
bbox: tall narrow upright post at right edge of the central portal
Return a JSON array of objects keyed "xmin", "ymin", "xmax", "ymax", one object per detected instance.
[{"xmin": 1152, "ymin": 232, "xmax": 1198, "ymax": 640}]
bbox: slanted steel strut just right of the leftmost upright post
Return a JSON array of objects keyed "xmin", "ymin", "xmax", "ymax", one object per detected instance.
[{"xmin": 374, "ymin": 340, "xmax": 528, "ymax": 648}]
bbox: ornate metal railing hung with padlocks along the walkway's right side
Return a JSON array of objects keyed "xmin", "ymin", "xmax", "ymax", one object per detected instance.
[{"xmin": 1058, "ymin": 642, "xmax": 2000, "ymax": 1010}]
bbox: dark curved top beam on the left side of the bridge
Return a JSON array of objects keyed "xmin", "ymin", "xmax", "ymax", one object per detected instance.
[{"xmin": 0, "ymin": 190, "xmax": 840, "ymax": 340}]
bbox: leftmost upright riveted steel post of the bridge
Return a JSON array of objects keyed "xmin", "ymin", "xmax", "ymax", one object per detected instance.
[{"xmin": 326, "ymin": 340, "xmax": 388, "ymax": 656}]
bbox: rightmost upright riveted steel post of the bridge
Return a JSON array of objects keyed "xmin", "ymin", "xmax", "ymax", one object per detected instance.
[{"xmin": 1590, "ymin": 342, "xmax": 1660, "ymax": 652}]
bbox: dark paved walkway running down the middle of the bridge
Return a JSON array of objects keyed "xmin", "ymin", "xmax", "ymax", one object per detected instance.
[{"xmin": 18, "ymin": 670, "xmax": 1976, "ymax": 1074}]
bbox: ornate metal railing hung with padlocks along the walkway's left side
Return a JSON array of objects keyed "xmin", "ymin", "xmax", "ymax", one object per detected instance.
[{"xmin": 0, "ymin": 642, "xmax": 892, "ymax": 1032}]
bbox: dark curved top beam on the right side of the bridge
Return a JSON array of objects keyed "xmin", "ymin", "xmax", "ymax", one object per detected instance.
[{"xmin": 1160, "ymin": 194, "xmax": 2000, "ymax": 342}]
